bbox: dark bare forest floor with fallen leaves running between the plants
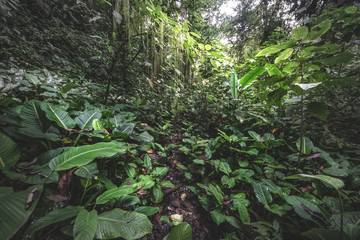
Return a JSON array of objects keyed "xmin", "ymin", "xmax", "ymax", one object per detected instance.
[{"xmin": 141, "ymin": 129, "xmax": 220, "ymax": 240}]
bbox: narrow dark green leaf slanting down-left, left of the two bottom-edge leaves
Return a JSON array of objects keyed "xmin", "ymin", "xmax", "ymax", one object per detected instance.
[{"xmin": 26, "ymin": 206, "xmax": 83, "ymax": 234}]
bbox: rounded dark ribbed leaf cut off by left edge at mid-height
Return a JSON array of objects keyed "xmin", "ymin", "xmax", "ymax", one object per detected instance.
[{"xmin": 0, "ymin": 132, "xmax": 21, "ymax": 170}]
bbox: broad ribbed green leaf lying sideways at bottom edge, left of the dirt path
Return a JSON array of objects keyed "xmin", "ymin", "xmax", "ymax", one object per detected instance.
[{"xmin": 96, "ymin": 208, "xmax": 152, "ymax": 239}]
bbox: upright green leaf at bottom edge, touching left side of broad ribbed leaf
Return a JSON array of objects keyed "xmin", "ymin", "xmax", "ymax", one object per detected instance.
[{"xmin": 73, "ymin": 209, "xmax": 98, "ymax": 240}]
